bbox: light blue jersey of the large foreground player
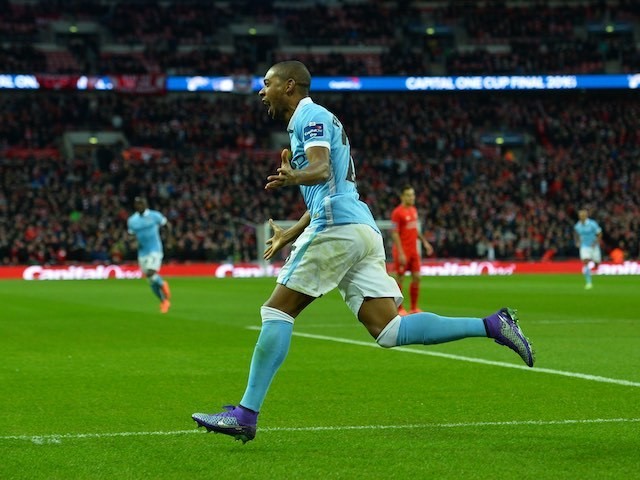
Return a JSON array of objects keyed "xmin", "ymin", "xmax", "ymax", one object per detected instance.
[{"xmin": 287, "ymin": 97, "xmax": 379, "ymax": 232}]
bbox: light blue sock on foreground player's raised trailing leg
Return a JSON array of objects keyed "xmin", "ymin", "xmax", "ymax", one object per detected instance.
[{"xmin": 397, "ymin": 312, "xmax": 487, "ymax": 345}]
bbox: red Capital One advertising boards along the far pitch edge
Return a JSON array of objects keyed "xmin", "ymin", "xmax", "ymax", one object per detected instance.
[{"xmin": 0, "ymin": 260, "xmax": 640, "ymax": 281}]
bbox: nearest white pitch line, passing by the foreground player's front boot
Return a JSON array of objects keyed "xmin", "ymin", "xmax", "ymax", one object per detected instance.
[{"xmin": 0, "ymin": 418, "xmax": 640, "ymax": 445}]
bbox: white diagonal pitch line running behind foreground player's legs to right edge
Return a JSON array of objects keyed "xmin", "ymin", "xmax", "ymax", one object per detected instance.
[{"xmin": 247, "ymin": 327, "xmax": 640, "ymax": 387}]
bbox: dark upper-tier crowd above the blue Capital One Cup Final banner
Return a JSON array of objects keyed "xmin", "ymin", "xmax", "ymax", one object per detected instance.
[{"xmin": 0, "ymin": 0, "xmax": 640, "ymax": 75}]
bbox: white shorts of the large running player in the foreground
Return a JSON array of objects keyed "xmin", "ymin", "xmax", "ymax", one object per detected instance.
[{"xmin": 278, "ymin": 224, "xmax": 403, "ymax": 316}]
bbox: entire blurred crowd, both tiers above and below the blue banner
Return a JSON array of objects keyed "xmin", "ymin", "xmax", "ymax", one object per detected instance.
[{"xmin": 0, "ymin": 0, "xmax": 640, "ymax": 265}]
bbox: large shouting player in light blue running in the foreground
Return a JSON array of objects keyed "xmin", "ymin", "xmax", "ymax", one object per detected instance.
[{"xmin": 192, "ymin": 61, "xmax": 534, "ymax": 442}]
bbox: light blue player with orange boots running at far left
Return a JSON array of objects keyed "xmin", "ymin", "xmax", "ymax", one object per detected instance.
[{"xmin": 127, "ymin": 197, "xmax": 171, "ymax": 313}]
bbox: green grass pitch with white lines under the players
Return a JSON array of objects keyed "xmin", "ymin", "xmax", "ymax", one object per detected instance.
[{"xmin": 0, "ymin": 274, "xmax": 640, "ymax": 480}]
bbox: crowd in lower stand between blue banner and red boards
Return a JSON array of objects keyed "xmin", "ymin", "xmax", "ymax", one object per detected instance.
[{"xmin": 0, "ymin": 89, "xmax": 640, "ymax": 264}]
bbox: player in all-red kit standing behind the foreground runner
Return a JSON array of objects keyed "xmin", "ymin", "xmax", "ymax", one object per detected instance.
[{"xmin": 391, "ymin": 185, "xmax": 433, "ymax": 315}]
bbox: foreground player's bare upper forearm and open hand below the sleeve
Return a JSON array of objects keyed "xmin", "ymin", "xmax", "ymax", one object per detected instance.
[{"xmin": 264, "ymin": 147, "xmax": 330, "ymax": 190}]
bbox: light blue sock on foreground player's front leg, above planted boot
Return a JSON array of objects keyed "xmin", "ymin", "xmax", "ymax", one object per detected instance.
[{"xmin": 240, "ymin": 320, "xmax": 293, "ymax": 412}]
